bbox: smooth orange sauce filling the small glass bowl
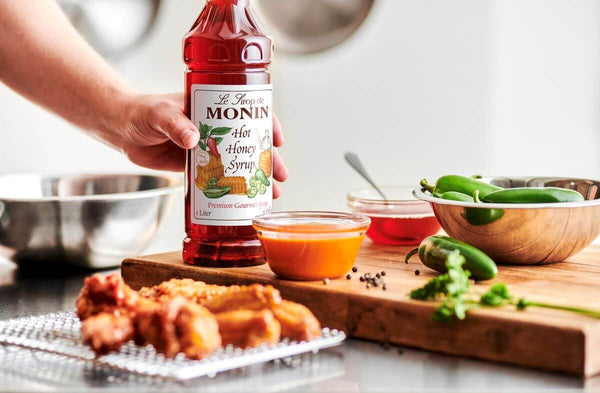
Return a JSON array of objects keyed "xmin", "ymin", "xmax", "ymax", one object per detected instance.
[{"xmin": 255, "ymin": 214, "xmax": 368, "ymax": 280}]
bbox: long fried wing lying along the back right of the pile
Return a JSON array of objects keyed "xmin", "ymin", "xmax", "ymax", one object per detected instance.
[{"xmin": 202, "ymin": 284, "xmax": 281, "ymax": 314}]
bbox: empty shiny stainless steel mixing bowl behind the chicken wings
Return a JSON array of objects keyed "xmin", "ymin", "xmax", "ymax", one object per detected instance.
[{"xmin": 0, "ymin": 174, "xmax": 182, "ymax": 269}]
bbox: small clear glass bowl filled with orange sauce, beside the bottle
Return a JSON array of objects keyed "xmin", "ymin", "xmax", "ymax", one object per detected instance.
[{"xmin": 253, "ymin": 211, "xmax": 371, "ymax": 280}]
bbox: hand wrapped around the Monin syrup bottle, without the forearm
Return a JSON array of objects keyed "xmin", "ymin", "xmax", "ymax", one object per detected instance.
[{"xmin": 120, "ymin": 93, "xmax": 288, "ymax": 198}]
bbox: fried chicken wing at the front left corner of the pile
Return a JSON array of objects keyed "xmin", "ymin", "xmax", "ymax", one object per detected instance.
[{"xmin": 81, "ymin": 312, "xmax": 134, "ymax": 355}]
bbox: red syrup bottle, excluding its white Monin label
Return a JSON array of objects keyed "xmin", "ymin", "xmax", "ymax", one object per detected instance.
[{"xmin": 183, "ymin": 0, "xmax": 272, "ymax": 267}]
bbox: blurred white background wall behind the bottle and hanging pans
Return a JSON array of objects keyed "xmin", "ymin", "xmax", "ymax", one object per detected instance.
[{"xmin": 0, "ymin": 0, "xmax": 600, "ymax": 252}]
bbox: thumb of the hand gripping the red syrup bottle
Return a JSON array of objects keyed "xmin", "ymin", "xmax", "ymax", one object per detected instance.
[{"xmin": 152, "ymin": 101, "xmax": 200, "ymax": 149}]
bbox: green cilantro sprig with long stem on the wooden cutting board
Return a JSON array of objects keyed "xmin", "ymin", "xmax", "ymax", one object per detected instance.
[{"xmin": 410, "ymin": 250, "xmax": 600, "ymax": 323}]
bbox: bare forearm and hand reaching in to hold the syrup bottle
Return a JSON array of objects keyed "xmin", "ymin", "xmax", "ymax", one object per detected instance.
[{"xmin": 0, "ymin": 0, "xmax": 287, "ymax": 178}]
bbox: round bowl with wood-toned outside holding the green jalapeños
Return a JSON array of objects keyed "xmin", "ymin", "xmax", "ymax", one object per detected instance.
[{"xmin": 413, "ymin": 177, "xmax": 600, "ymax": 265}]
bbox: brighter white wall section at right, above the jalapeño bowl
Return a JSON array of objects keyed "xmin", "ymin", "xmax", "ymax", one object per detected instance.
[{"xmin": 488, "ymin": 0, "xmax": 600, "ymax": 179}]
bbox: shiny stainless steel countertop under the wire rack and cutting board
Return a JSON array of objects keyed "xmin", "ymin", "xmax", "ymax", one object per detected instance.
[{"xmin": 0, "ymin": 262, "xmax": 600, "ymax": 393}]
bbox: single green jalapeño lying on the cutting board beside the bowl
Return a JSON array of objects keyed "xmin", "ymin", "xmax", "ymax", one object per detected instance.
[{"xmin": 405, "ymin": 236, "xmax": 498, "ymax": 281}]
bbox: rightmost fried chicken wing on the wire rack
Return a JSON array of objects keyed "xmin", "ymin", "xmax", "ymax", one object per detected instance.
[{"xmin": 271, "ymin": 300, "xmax": 321, "ymax": 341}]
